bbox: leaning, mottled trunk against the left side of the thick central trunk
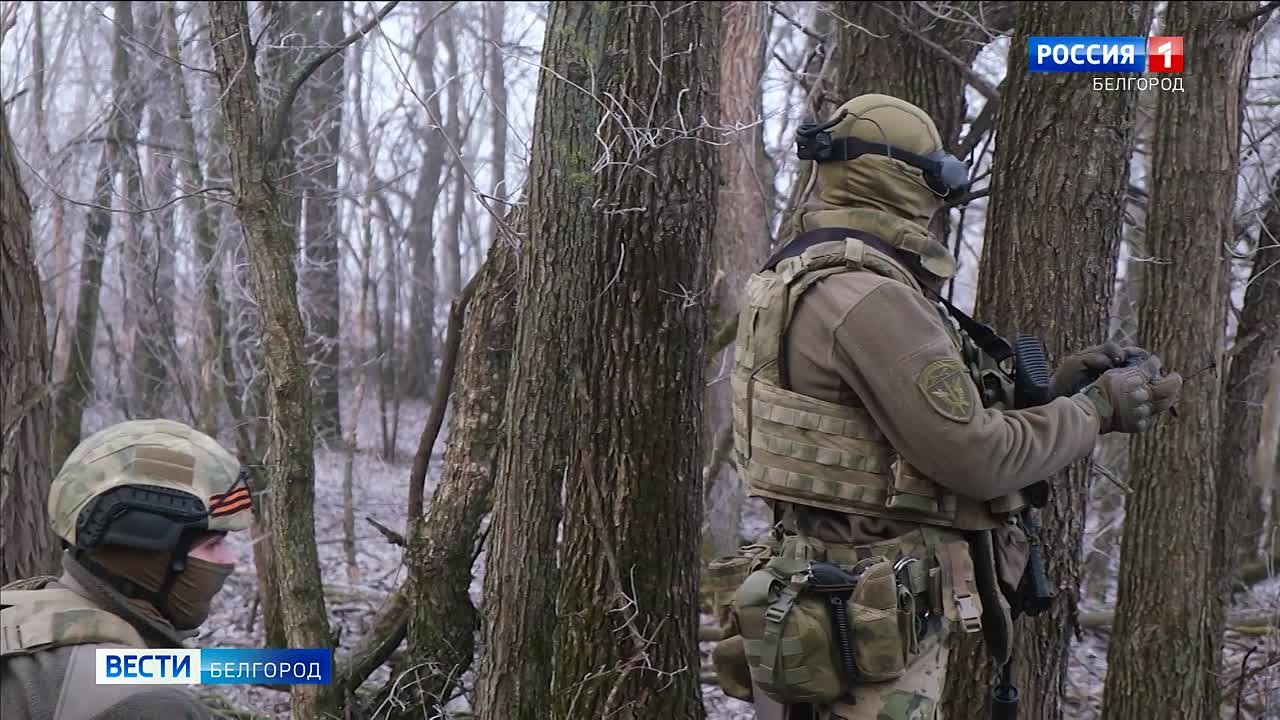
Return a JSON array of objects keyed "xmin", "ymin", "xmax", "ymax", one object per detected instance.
[{"xmin": 403, "ymin": 238, "xmax": 518, "ymax": 716}]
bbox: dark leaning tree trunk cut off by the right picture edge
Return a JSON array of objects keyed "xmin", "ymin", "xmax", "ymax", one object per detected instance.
[{"xmin": 1215, "ymin": 172, "xmax": 1280, "ymax": 571}]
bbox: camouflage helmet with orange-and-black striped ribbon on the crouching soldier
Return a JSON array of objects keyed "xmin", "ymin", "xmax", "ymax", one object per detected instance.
[{"xmin": 49, "ymin": 420, "xmax": 253, "ymax": 551}]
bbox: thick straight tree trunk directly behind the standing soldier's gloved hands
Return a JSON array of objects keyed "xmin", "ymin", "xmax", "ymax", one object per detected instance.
[{"xmin": 1102, "ymin": 3, "xmax": 1254, "ymax": 720}]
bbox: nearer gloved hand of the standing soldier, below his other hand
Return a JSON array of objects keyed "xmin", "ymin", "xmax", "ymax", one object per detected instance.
[{"xmin": 1082, "ymin": 354, "xmax": 1183, "ymax": 434}]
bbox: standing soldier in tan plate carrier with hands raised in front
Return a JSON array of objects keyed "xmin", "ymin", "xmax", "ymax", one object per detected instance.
[{"xmin": 708, "ymin": 95, "xmax": 1181, "ymax": 720}]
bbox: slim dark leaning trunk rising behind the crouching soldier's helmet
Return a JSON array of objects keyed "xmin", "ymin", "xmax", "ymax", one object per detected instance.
[{"xmin": 52, "ymin": 3, "xmax": 133, "ymax": 469}]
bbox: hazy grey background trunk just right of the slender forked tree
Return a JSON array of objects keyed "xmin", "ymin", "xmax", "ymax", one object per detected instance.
[{"xmin": 298, "ymin": 1, "xmax": 346, "ymax": 441}]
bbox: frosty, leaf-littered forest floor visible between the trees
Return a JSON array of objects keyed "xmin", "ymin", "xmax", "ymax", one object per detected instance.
[{"xmin": 177, "ymin": 404, "xmax": 1280, "ymax": 720}]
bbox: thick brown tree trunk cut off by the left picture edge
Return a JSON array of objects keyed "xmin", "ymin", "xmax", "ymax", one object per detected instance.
[{"xmin": 0, "ymin": 102, "xmax": 56, "ymax": 585}]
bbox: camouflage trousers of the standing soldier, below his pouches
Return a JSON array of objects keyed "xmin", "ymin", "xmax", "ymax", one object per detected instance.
[{"xmin": 755, "ymin": 617, "xmax": 948, "ymax": 720}]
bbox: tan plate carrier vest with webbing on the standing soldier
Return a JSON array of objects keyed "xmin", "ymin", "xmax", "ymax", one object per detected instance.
[{"xmin": 732, "ymin": 226, "xmax": 1024, "ymax": 530}]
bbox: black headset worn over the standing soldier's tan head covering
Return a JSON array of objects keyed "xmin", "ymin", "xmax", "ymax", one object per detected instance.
[{"xmin": 796, "ymin": 110, "xmax": 970, "ymax": 202}]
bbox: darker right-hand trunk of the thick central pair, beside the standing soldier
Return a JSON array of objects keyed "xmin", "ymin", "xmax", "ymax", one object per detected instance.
[{"xmin": 540, "ymin": 3, "xmax": 721, "ymax": 720}]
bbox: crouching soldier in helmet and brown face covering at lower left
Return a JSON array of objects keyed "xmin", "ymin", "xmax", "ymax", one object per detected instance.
[{"xmin": 0, "ymin": 420, "xmax": 252, "ymax": 720}]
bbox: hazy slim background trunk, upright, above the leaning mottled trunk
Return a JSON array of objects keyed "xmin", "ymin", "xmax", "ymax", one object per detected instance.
[{"xmin": 399, "ymin": 3, "xmax": 445, "ymax": 397}]
